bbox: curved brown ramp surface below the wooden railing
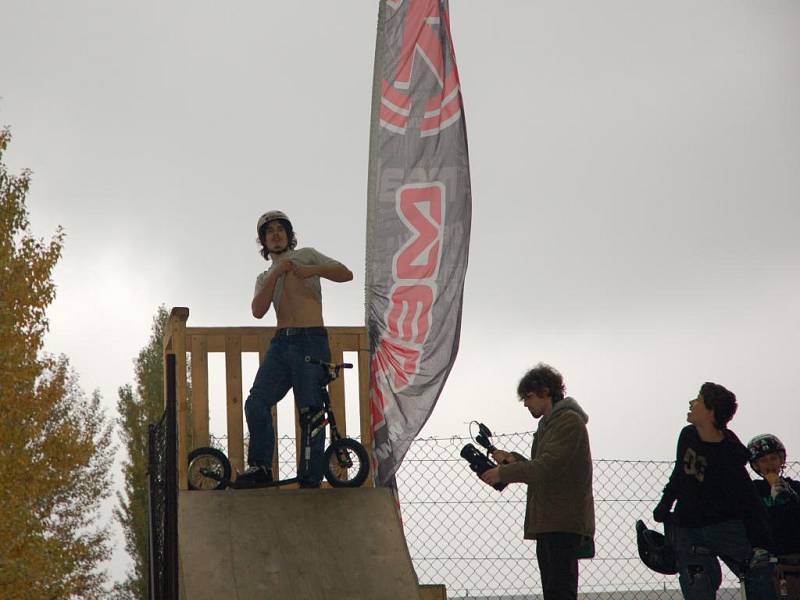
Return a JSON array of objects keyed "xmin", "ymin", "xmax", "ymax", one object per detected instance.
[{"xmin": 178, "ymin": 488, "xmax": 420, "ymax": 600}]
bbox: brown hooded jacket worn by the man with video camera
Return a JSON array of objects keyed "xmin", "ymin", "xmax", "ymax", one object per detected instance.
[{"xmin": 499, "ymin": 398, "xmax": 594, "ymax": 539}]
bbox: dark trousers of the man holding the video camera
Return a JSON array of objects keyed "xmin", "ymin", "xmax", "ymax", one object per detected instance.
[{"xmin": 536, "ymin": 532, "xmax": 581, "ymax": 600}]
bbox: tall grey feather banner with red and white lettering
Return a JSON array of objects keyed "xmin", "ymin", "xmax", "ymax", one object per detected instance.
[{"xmin": 366, "ymin": 0, "xmax": 472, "ymax": 485}]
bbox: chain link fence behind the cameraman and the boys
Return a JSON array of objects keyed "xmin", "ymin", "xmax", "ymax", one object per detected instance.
[{"xmin": 213, "ymin": 432, "xmax": 800, "ymax": 600}]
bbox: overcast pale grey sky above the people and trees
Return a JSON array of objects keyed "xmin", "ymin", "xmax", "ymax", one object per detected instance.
[{"xmin": 0, "ymin": 0, "xmax": 800, "ymax": 588}]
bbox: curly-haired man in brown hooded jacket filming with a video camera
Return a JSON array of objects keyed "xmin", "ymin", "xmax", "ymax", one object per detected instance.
[{"xmin": 481, "ymin": 363, "xmax": 594, "ymax": 600}]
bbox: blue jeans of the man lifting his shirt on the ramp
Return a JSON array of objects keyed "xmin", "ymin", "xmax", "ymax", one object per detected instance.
[{"xmin": 244, "ymin": 328, "xmax": 331, "ymax": 484}]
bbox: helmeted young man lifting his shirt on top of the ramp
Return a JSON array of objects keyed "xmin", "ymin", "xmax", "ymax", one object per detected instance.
[{"xmin": 235, "ymin": 210, "xmax": 353, "ymax": 488}]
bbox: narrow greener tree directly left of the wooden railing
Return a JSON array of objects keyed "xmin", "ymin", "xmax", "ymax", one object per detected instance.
[{"xmin": 114, "ymin": 306, "xmax": 169, "ymax": 600}]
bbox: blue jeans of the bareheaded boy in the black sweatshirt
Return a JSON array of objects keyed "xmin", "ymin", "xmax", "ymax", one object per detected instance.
[{"xmin": 675, "ymin": 521, "xmax": 776, "ymax": 600}]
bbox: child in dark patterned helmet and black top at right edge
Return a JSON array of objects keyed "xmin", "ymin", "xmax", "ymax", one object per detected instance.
[{"xmin": 747, "ymin": 433, "xmax": 800, "ymax": 600}]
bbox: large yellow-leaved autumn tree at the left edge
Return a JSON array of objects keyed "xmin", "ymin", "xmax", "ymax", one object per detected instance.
[{"xmin": 0, "ymin": 129, "xmax": 114, "ymax": 600}]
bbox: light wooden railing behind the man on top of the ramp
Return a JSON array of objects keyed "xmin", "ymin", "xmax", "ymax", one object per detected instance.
[{"xmin": 164, "ymin": 307, "xmax": 372, "ymax": 490}]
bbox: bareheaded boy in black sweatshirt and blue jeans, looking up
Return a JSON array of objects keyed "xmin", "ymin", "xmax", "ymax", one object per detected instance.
[{"xmin": 653, "ymin": 382, "xmax": 775, "ymax": 600}]
